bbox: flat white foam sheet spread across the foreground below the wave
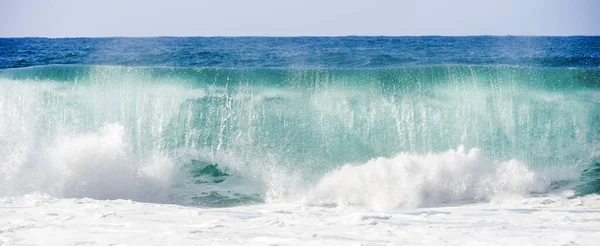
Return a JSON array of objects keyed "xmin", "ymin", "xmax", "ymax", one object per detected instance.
[{"xmin": 0, "ymin": 194, "xmax": 600, "ymax": 245}]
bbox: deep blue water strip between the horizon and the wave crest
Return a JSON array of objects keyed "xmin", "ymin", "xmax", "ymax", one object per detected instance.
[{"xmin": 0, "ymin": 36, "xmax": 600, "ymax": 68}]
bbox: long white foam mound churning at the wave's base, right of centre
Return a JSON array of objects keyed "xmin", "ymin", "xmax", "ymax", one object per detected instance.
[{"xmin": 304, "ymin": 147, "xmax": 549, "ymax": 209}]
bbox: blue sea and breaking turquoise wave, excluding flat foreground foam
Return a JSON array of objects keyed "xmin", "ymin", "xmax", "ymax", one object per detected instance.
[{"xmin": 0, "ymin": 37, "xmax": 600, "ymax": 209}]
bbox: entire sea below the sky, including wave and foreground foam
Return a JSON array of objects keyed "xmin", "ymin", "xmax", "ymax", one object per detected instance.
[{"xmin": 0, "ymin": 37, "xmax": 600, "ymax": 245}]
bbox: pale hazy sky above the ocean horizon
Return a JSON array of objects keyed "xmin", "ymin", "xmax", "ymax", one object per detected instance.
[{"xmin": 0, "ymin": 0, "xmax": 600, "ymax": 37}]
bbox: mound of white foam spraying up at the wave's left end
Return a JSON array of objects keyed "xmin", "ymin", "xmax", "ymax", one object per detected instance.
[{"xmin": 8, "ymin": 123, "xmax": 173, "ymax": 201}]
